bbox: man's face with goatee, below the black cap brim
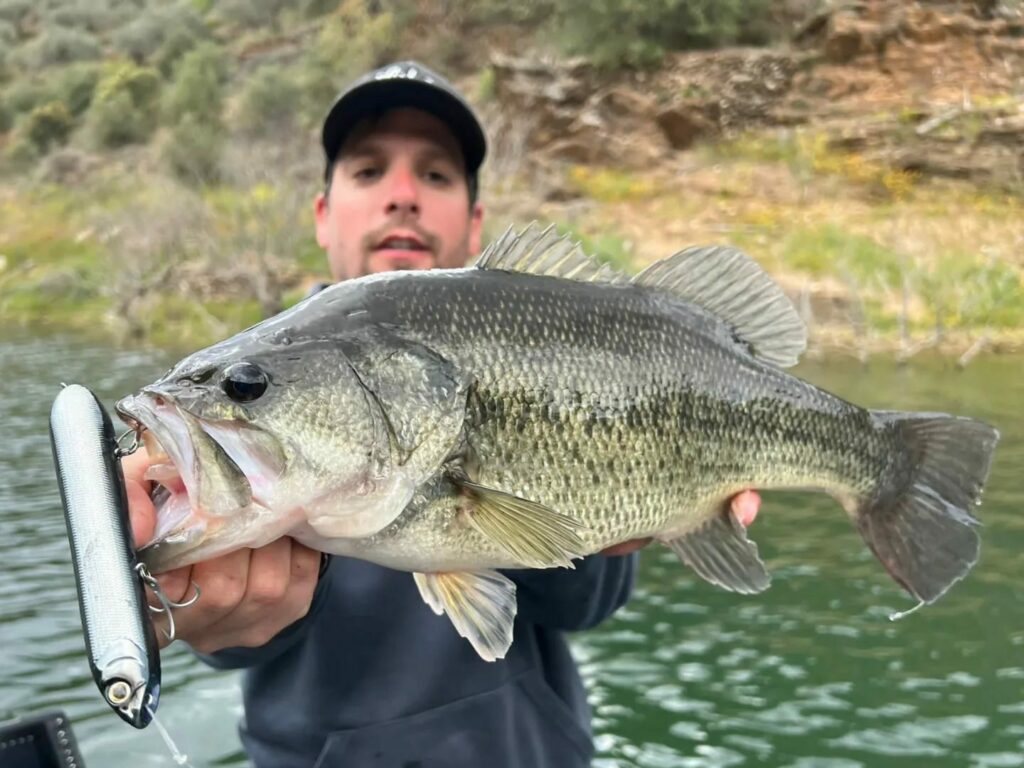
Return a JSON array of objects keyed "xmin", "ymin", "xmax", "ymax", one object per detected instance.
[{"xmin": 316, "ymin": 109, "xmax": 483, "ymax": 281}]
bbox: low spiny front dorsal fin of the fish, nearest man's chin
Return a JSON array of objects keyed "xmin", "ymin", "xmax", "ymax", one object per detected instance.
[{"xmin": 473, "ymin": 222, "xmax": 629, "ymax": 283}]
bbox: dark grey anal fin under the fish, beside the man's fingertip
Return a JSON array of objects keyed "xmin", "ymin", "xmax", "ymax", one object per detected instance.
[{"xmin": 665, "ymin": 510, "xmax": 771, "ymax": 595}]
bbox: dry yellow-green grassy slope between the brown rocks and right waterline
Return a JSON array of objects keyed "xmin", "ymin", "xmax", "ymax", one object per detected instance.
[{"xmin": 505, "ymin": 136, "xmax": 1024, "ymax": 358}]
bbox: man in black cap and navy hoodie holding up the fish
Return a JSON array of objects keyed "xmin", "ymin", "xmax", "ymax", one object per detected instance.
[{"xmin": 125, "ymin": 61, "xmax": 758, "ymax": 768}]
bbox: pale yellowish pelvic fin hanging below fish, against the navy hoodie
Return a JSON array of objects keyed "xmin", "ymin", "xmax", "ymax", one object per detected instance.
[{"xmin": 413, "ymin": 570, "xmax": 516, "ymax": 662}]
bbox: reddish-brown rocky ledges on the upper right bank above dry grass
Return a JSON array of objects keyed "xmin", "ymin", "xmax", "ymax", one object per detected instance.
[{"xmin": 493, "ymin": 0, "xmax": 1024, "ymax": 190}]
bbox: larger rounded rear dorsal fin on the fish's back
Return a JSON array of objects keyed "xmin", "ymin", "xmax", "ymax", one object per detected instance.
[{"xmin": 633, "ymin": 246, "xmax": 807, "ymax": 368}]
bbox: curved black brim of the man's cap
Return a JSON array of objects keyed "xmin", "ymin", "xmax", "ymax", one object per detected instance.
[{"xmin": 322, "ymin": 79, "xmax": 486, "ymax": 173}]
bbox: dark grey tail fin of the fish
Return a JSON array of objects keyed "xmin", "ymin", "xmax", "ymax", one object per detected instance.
[{"xmin": 854, "ymin": 411, "xmax": 999, "ymax": 603}]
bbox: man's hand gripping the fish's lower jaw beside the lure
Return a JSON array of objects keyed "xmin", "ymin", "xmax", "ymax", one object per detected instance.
[{"xmin": 123, "ymin": 451, "xmax": 321, "ymax": 653}]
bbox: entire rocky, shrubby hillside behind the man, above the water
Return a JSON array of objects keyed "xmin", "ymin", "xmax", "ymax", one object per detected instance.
[{"xmin": 0, "ymin": 0, "xmax": 1024, "ymax": 357}]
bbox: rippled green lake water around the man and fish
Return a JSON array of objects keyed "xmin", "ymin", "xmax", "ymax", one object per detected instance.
[{"xmin": 0, "ymin": 340, "xmax": 1024, "ymax": 768}]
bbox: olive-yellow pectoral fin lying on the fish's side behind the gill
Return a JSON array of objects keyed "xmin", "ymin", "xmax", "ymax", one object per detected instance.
[{"xmin": 456, "ymin": 480, "xmax": 584, "ymax": 568}]
